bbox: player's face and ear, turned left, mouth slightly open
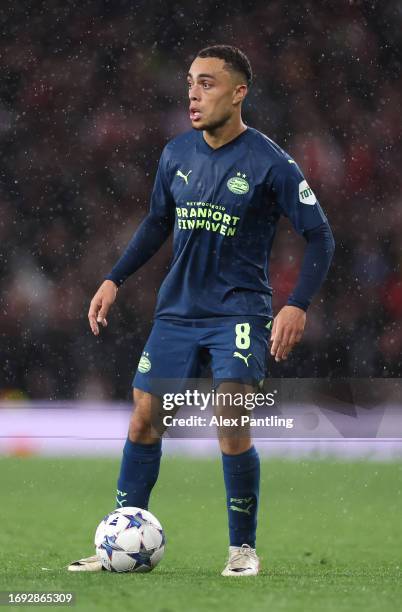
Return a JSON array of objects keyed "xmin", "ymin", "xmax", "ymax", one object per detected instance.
[{"xmin": 187, "ymin": 57, "xmax": 243, "ymax": 131}]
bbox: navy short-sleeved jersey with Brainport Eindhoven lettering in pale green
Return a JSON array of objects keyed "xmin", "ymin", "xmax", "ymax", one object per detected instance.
[{"xmin": 144, "ymin": 127, "xmax": 326, "ymax": 319}]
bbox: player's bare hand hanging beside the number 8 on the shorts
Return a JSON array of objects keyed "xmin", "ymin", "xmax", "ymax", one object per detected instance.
[{"xmin": 270, "ymin": 306, "xmax": 306, "ymax": 361}]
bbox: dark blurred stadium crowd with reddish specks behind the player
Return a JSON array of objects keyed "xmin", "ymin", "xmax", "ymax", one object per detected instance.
[{"xmin": 0, "ymin": 0, "xmax": 402, "ymax": 400}]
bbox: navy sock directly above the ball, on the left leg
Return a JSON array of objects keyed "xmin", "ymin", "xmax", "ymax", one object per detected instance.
[{"xmin": 116, "ymin": 438, "xmax": 162, "ymax": 510}]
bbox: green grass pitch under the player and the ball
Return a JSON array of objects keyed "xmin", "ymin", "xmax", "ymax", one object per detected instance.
[{"xmin": 0, "ymin": 457, "xmax": 402, "ymax": 612}]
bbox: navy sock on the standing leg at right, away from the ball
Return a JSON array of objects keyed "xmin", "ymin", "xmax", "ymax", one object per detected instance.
[{"xmin": 222, "ymin": 446, "xmax": 260, "ymax": 548}]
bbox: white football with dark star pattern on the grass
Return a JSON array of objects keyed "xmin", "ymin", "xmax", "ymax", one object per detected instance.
[{"xmin": 95, "ymin": 507, "xmax": 165, "ymax": 572}]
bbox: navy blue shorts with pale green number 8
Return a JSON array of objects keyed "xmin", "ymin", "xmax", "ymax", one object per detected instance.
[{"xmin": 133, "ymin": 317, "xmax": 272, "ymax": 395}]
